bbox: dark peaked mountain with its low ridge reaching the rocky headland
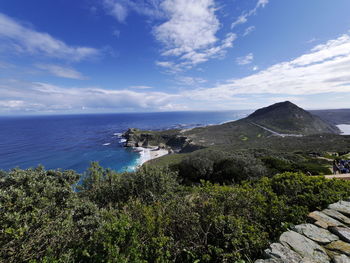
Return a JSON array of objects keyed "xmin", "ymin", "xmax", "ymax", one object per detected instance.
[{"xmin": 124, "ymin": 101, "xmax": 342, "ymax": 152}]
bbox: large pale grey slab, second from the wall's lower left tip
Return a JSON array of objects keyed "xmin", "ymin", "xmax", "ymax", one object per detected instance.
[{"xmin": 280, "ymin": 231, "xmax": 330, "ymax": 263}]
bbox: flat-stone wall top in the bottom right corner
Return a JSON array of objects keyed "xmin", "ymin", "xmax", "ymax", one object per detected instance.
[{"xmin": 255, "ymin": 199, "xmax": 350, "ymax": 263}]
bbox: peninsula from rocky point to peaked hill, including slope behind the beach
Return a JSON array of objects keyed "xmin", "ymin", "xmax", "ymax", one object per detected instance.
[{"xmin": 123, "ymin": 101, "xmax": 350, "ymax": 174}]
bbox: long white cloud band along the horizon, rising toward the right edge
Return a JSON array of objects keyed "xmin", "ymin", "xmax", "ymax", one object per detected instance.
[{"xmin": 5, "ymin": 31, "xmax": 350, "ymax": 113}]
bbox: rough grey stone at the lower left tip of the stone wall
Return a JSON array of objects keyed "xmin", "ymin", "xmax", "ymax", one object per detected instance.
[{"xmin": 265, "ymin": 243, "xmax": 302, "ymax": 263}]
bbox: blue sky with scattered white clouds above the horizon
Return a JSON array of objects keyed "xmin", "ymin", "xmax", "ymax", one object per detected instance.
[{"xmin": 0, "ymin": 0, "xmax": 350, "ymax": 115}]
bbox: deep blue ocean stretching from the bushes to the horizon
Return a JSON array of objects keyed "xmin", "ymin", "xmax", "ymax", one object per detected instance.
[{"xmin": 0, "ymin": 111, "xmax": 249, "ymax": 173}]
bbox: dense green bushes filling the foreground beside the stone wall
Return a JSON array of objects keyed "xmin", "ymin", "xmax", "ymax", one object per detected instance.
[{"xmin": 0, "ymin": 164, "xmax": 350, "ymax": 262}]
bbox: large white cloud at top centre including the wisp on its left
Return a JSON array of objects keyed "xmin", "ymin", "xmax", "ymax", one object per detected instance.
[{"xmin": 103, "ymin": 0, "xmax": 236, "ymax": 72}]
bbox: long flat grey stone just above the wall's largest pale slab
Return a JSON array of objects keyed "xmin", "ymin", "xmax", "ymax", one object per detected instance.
[{"xmin": 294, "ymin": 224, "xmax": 339, "ymax": 244}]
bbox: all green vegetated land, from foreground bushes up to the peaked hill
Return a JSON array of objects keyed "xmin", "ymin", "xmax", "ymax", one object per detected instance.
[{"xmin": 0, "ymin": 102, "xmax": 350, "ymax": 263}]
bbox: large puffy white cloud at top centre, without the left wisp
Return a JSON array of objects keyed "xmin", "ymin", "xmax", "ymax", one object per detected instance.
[{"xmin": 153, "ymin": 0, "xmax": 236, "ymax": 69}]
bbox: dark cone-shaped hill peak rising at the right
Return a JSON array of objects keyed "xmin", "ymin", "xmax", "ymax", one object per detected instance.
[{"xmin": 246, "ymin": 101, "xmax": 340, "ymax": 135}]
